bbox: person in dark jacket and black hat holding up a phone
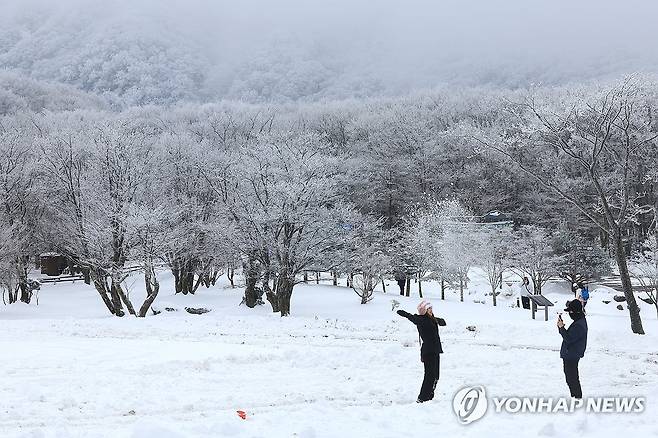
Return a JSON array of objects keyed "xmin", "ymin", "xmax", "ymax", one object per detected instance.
[{"xmin": 557, "ymin": 300, "xmax": 587, "ymax": 398}]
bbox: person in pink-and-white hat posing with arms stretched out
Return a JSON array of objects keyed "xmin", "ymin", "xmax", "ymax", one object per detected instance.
[{"xmin": 398, "ymin": 300, "xmax": 446, "ymax": 403}]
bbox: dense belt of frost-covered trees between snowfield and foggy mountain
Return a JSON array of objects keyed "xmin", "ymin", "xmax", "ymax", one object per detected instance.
[{"xmin": 0, "ymin": 71, "xmax": 658, "ymax": 333}]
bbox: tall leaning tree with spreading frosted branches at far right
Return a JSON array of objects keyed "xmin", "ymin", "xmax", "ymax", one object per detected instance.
[{"xmin": 479, "ymin": 78, "xmax": 658, "ymax": 334}]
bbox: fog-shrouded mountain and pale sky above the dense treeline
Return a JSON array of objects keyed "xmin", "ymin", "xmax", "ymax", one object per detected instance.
[{"xmin": 0, "ymin": 0, "xmax": 658, "ymax": 106}]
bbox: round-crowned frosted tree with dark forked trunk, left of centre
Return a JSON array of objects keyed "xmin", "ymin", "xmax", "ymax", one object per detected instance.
[{"xmin": 207, "ymin": 132, "xmax": 343, "ymax": 316}]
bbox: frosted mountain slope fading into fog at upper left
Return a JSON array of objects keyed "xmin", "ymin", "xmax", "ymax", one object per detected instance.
[{"xmin": 0, "ymin": 4, "xmax": 208, "ymax": 105}]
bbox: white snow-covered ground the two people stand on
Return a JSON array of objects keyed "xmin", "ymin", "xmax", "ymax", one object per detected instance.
[{"xmin": 0, "ymin": 273, "xmax": 658, "ymax": 438}]
